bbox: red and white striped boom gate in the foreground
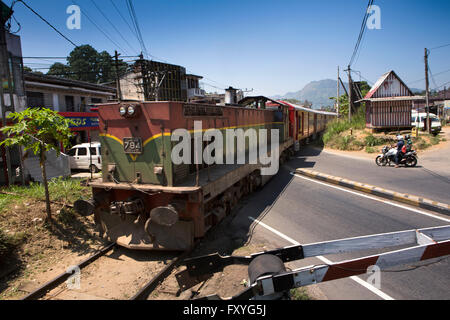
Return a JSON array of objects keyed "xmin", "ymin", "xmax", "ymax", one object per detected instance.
[{"xmin": 177, "ymin": 226, "xmax": 450, "ymax": 300}]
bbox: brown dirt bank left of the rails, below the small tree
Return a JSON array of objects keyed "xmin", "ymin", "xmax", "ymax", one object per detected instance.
[{"xmin": 0, "ymin": 200, "xmax": 105, "ymax": 299}]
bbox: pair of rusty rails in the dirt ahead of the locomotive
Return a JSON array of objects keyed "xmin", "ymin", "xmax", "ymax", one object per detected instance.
[{"xmin": 22, "ymin": 243, "xmax": 197, "ymax": 300}]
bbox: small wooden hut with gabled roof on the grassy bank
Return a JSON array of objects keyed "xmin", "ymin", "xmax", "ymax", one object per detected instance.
[{"xmin": 358, "ymin": 70, "xmax": 423, "ymax": 131}]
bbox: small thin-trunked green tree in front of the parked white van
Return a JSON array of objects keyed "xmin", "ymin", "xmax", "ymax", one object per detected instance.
[{"xmin": 0, "ymin": 108, "xmax": 74, "ymax": 221}]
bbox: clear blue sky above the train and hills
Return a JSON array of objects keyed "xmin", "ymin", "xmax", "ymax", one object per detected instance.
[{"xmin": 4, "ymin": 0, "xmax": 450, "ymax": 95}]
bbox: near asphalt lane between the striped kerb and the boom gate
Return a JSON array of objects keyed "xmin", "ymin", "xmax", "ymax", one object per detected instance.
[{"xmin": 233, "ymin": 162, "xmax": 450, "ymax": 300}]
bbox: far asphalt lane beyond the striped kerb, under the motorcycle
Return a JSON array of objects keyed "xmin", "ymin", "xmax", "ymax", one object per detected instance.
[{"xmin": 289, "ymin": 147, "xmax": 450, "ymax": 203}]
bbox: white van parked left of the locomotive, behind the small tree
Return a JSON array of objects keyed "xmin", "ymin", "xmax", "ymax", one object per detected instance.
[{"xmin": 67, "ymin": 142, "xmax": 102, "ymax": 172}]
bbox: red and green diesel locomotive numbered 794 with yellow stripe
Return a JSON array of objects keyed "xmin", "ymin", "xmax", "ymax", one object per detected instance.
[{"xmin": 75, "ymin": 99, "xmax": 294, "ymax": 250}]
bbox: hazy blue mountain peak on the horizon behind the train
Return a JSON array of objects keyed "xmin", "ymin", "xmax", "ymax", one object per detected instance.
[{"xmin": 272, "ymin": 79, "xmax": 348, "ymax": 109}]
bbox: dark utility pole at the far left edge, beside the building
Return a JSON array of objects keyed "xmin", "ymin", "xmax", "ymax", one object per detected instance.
[{"xmin": 0, "ymin": 1, "xmax": 14, "ymax": 185}]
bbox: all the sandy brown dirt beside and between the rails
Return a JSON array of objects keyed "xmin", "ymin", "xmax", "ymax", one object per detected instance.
[{"xmin": 0, "ymin": 174, "xmax": 324, "ymax": 300}]
